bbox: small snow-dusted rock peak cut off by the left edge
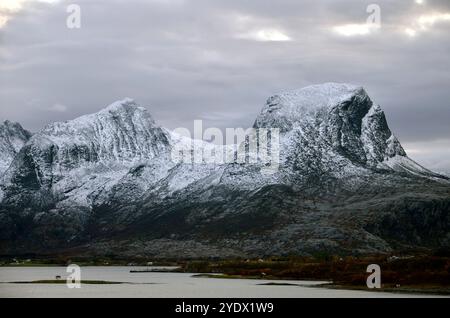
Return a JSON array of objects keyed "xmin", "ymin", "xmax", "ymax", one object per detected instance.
[{"xmin": 0, "ymin": 120, "xmax": 31, "ymax": 176}]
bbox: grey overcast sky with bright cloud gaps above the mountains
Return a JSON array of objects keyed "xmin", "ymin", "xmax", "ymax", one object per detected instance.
[{"xmin": 0, "ymin": 0, "xmax": 450, "ymax": 171}]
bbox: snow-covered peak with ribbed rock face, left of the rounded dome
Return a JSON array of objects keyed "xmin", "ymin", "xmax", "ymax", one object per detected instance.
[{"xmin": 2, "ymin": 99, "xmax": 170, "ymax": 194}]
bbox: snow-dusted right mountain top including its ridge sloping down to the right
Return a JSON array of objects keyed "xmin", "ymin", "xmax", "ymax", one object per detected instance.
[{"xmin": 254, "ymin": 83, "xmax": 441, "ymax": 184}]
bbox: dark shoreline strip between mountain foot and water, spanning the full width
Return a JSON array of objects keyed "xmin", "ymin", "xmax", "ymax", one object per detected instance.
[{"xmin": 0, "ymin": 254, "xmax": 450, "ymax": 296}]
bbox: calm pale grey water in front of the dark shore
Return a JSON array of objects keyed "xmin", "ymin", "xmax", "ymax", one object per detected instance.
[{"xmin": 0, "ymin": 266, "xmax": 442, "ymax": 298}]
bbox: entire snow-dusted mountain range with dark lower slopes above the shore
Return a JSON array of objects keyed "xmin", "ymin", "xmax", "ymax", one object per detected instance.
[{"xmin": 0, "ymin": 83, "xmax": 450, "ymax": 258}]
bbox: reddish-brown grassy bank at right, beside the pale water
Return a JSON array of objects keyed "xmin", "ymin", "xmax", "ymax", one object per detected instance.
[{"xmin": 182, "ymin": 255, "xmax": 450, "ymax": 293}]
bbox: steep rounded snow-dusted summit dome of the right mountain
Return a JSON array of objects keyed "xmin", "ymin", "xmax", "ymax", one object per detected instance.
[{"xmin": 254, "ymin": 83, "xmax": 406, "ymax": 167}]
